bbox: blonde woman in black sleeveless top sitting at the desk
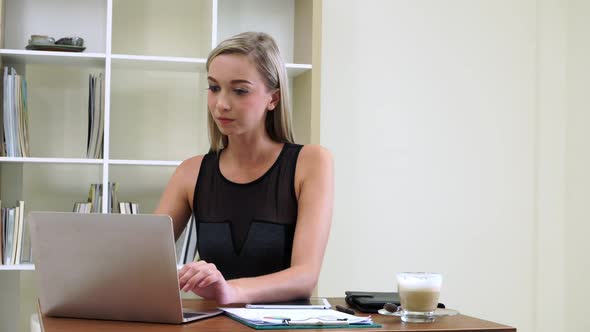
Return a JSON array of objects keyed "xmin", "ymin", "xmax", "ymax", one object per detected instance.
[{"xmin": 155, "ymin": 32, "xmax": 333, "ymax": 304}]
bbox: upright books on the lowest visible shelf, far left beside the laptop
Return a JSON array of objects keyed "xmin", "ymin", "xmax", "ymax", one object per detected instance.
[{"xmin": 0, "ymin": 201, "xmax": 32, "ymax": 265}]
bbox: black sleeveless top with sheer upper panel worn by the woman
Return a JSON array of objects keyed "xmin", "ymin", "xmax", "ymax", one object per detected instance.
[{"xmin": 193, "ymin": 143, "xmax": 302, "ymax": 280}]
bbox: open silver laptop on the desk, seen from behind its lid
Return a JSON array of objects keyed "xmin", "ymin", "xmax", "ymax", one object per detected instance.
[{"xmin": 28, "ymin": 212, "xmax": 223, "ymax": 324}]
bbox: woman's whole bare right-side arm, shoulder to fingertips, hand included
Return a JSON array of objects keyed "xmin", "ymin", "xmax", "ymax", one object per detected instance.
[{"xmin": 180, "ymin": 145, "xmax": 334, "ymax": 304}]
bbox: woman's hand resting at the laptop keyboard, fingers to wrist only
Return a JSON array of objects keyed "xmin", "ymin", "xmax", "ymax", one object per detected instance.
[{"xmin": 178, "ymin": 261, "xmax": 235, "ymax": 304}]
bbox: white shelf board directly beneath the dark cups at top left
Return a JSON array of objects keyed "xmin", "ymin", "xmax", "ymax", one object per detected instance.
[{"xmin": 0, "ymin": 49, "xmax": 106, "ymax": 67}]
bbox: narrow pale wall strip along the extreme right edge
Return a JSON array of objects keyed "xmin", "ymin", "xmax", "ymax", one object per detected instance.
[{"xmin": 565, "ymin": 0, "xmax": 590, "ymax": 332}]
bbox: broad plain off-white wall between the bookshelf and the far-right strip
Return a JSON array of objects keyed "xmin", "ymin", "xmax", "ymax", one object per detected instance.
[{"xmin": 318, "ymin": 0, "xmax": 590, "ymax": 332}]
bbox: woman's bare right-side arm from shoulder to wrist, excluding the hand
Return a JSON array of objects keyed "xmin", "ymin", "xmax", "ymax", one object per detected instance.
[{"xmin": 229, "ymin": 145, "xmax": 334, "ymax": 303}]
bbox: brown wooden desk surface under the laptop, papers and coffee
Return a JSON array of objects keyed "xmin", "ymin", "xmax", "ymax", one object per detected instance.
[{"xmin": 39, "ymin": 298, "xmax": 516, "ymax": 332}]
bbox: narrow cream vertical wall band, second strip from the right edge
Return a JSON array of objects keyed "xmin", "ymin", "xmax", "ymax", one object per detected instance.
[{"xmin": 532, "ymin": 0, "xmax": 567, "ymax": 331}]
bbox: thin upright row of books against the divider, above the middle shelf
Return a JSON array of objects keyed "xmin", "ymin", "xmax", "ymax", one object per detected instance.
[{"xmin": 86, "ymin": 74, "xmax": 104, "ymax": 159}]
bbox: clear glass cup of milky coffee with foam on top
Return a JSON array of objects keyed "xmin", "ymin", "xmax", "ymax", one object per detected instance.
[{"xmin": 396, "ymin": 272, "xmax": 442, "ymax": 323}]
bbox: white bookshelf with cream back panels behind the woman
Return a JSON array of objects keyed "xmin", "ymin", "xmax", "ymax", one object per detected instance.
[{"xmin": 0, "ymin": 0, "xmax": 321, "ymax": 330}]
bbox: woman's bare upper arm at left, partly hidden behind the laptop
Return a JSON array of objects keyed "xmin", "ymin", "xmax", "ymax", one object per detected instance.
[{"xmin": 154, "ymin": 156, "xmax": 203, "ymax": 240}]
